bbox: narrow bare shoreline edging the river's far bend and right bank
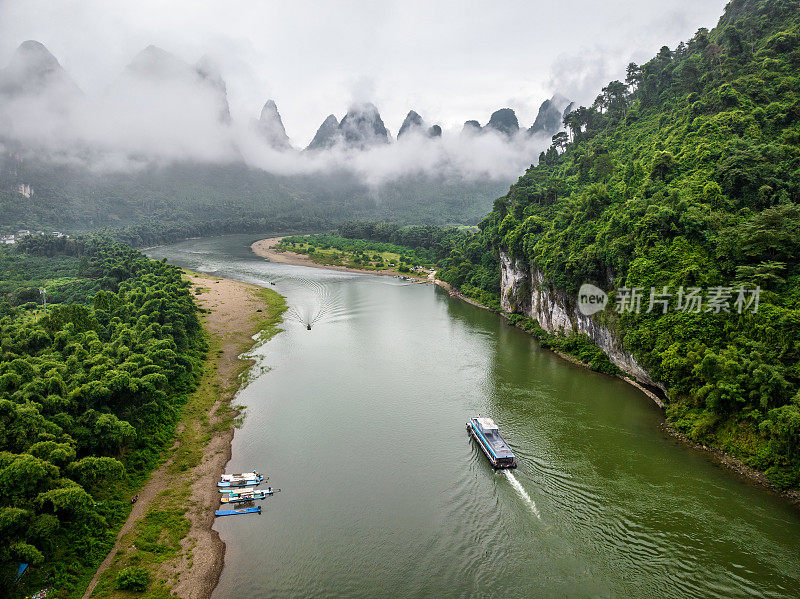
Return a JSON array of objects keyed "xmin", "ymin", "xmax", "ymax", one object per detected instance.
[{"xmin": 250, "ymin": 237, "xmax": 800, "ymax": 509}]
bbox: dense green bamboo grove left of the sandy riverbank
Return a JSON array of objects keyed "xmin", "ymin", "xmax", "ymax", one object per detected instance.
[{"xmin": 0, "ymin": 237, "xmax": 205, "ymax": 596}]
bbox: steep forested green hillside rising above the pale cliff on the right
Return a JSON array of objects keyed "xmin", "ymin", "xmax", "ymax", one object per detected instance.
[{"xmin": 434, "ymin": 0, "xmax": 800, "ymax": 488}]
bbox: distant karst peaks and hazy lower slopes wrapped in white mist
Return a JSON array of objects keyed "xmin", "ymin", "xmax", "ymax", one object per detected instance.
[{"xmin": 0, "ymin": 37, "xmax": 576, "ymax": 231}]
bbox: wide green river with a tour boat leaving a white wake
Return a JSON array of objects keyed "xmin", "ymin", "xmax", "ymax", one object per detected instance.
[{"xmin": 148, "ymin": 236, "xmax": 800, "ymax": 599}]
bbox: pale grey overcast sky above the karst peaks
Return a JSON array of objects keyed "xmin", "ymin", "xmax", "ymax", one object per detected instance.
[{"xmin": 0, "ymin": 0, "xmax": 726, "ymax": 146}]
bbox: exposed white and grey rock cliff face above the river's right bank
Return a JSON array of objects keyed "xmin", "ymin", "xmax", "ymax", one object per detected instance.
[{"xmin": 500, "ymin": 251, "xmax": 666, "ymax": 392}]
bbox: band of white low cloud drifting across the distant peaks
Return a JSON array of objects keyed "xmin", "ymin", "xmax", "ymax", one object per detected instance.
[{"xmin": 0, "ymin": 63, "xmax": 550, "ymax": 186}]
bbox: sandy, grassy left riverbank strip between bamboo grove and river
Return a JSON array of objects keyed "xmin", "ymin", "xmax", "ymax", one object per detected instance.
[{"xmin": 83, "ymin": 271, "xmax": 286, "ymax": 599}]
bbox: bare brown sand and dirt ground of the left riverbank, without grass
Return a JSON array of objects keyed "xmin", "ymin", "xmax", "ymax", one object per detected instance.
[{"xmin": 83, "ymin": 274, "xmax": 278, "ymax": 599}]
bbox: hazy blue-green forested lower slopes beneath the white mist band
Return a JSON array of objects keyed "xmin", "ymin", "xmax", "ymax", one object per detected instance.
[{"xmin": 0, "ymin": 157, "xmax": 508, "ymax": 246}]
